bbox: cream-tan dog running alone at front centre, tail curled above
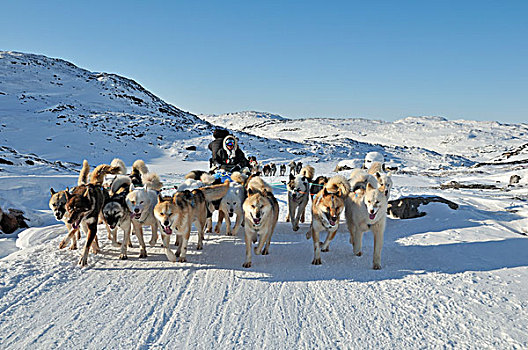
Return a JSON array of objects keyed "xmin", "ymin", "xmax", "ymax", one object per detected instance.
[{"xmin": 242, "ymin": 176, "xmax": 279, "ymax": 268}]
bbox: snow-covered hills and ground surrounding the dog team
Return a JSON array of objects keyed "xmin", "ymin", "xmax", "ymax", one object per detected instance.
[{"xmin": 0, "ymin": 52, "xmax": 528, "ymax": 349}]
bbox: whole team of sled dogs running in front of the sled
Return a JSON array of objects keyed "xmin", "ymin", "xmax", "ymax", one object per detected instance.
[{"xmin": 49, "ymin": 158, "xmax": 392, "ymax": 269}]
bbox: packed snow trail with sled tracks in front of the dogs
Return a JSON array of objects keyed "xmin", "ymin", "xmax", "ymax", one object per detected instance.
[{"xmin": 0, "ymin": 200, "xmax": 528, "ymax": 349}]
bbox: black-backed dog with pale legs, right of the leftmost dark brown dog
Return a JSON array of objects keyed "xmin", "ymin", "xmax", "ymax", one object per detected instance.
[{"xmin": 103, "ymin": 175, "xmax": 132, "ymax": 260}]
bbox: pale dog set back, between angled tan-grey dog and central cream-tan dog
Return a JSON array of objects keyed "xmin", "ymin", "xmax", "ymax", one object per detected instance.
[{"xmin": 215, "ymin": 182, "xmax": 246, "ymax": 236}]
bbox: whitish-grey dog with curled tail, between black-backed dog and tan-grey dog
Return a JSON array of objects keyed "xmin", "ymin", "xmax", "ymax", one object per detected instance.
[{"xmin": 126, "ymin": 173, "xmax": 163, "ymax": 258}]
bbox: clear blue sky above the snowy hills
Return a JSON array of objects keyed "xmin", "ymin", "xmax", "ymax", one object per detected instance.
[{"xmin": 0, "ymin": 0, "xmax": 528, "ymax": 122}]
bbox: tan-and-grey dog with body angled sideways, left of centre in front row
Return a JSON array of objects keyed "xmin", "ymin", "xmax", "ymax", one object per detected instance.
[{"xmin": 154, "ymin": 181, "xmax": 229, "ymax": 262}]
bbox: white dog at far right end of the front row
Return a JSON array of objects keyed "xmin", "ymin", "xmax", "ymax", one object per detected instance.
[{"xmin": 345, "ymin": 175, "xmax": 388, "ymax": 270}]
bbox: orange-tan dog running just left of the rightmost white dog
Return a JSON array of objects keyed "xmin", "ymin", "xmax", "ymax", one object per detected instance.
[{"xmin": 306, "ymin": 175, "xmax": 350, "ymax": 265}]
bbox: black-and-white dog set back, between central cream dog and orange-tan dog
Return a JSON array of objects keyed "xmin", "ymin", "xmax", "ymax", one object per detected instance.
[{"xmin": 286, "ymin": 165, "xmax": 314, "ymax": 231}]
